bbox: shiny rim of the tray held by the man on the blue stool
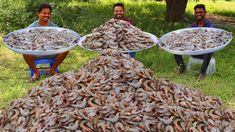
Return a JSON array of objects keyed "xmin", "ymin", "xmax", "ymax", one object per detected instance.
[{"xmin": 3, "ymin": 27, "xmax": 81, "ymax": 56}]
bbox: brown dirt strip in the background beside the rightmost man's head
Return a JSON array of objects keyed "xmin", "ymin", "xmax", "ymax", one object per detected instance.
[{"xmin": 206, "ymin": 13, "xmax": 235, "ymax": 28}]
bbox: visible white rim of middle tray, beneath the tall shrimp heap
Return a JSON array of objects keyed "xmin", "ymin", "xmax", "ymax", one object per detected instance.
[{"xmin": 78, "ymin": 32, "xmax": 158, "ymax": 53}]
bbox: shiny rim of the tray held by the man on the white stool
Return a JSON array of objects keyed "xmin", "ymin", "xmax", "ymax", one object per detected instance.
[{"xmin": 159, "ymin": 27, "xmax": 233, "ymax": 55}]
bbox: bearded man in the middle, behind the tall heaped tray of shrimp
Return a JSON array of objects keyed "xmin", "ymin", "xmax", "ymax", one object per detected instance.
[{"xmin": 113, "ymin": 3, "xmax": 136, "ymax": 58}]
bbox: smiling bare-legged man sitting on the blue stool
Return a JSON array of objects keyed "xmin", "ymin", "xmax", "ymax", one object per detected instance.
[{"xmin": 23, "ymin": 3, "xmax": 68, "ymax": 82}]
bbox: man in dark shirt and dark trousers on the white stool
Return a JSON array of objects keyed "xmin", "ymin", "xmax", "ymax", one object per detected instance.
[{"xmin": 174, "ymin": 4, "xmax": 214, "ymax": 80}]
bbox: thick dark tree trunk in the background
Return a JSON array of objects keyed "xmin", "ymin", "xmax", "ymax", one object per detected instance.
[{"xmin": 166, "ymin": 0, "xmax": 188, "ymax": 22}]
